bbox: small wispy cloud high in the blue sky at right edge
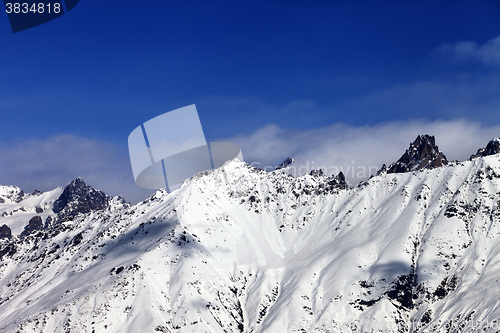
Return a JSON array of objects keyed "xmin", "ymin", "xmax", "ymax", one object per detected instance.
[{"xmin": 434, "ymin": 36, "xmax": 500, "ymax": 66}]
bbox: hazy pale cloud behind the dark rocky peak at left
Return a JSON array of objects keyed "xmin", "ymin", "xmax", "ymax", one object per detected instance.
[{"xmin": 0, "ymin": 134, "xmax": 153, "ymax": 203}]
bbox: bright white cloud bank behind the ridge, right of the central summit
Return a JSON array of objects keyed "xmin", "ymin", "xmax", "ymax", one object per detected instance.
[{"xmin": 226, "ymin": 119, "xmax": 500, "ymax": 184}]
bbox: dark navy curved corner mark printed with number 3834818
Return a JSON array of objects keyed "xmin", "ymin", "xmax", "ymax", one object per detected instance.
[{"xmin": 4, "ymin": 0, "xmax": 79, "ymax": 33}]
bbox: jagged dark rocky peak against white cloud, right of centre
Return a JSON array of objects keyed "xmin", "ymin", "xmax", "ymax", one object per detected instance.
[{"xmin": 387, "ymin": 134, "xmax": 448, "ymax": 173}]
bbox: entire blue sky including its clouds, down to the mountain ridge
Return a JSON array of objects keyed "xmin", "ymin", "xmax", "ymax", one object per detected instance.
[{"xmin": 0, "ymin": 0, "xmax": 500, "ymax": 201}]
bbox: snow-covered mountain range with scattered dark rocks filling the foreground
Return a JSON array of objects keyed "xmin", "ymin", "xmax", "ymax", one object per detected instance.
[{"xmin": 0, "ymin": 136, "xmax": 500, "ymax": 332}]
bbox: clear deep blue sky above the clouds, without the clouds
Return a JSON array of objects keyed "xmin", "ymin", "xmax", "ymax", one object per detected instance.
[{"xmin": 0, "ymin": 0, "xmax": 500, "ymax": 145}]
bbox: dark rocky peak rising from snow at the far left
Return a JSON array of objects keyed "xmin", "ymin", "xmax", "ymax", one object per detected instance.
[{"xmin": 52, "ymin": 178, "xmax": 109, "ymax": 218}]
